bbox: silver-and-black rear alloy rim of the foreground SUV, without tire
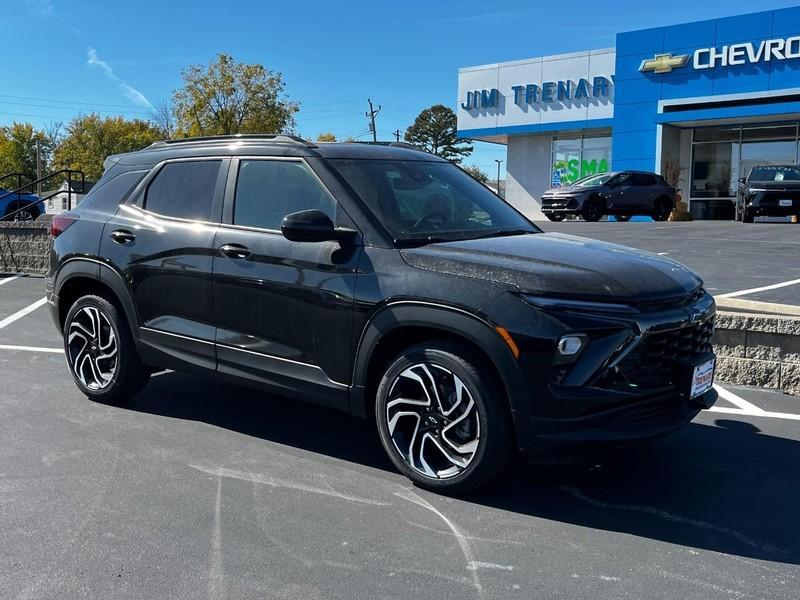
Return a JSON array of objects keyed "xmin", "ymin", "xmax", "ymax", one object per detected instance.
[{"xmin": 67, "ymin": 306, "xmax": 119, "ymax": 391}]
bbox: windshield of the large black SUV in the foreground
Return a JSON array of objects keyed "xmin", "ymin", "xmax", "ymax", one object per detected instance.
[{"xmin": 329, "ymin": 159, "xmax": 540, "ymax": 242}]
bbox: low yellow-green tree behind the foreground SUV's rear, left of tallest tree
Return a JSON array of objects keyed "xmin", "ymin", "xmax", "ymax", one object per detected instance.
[{"xmin": 54, "ymin": 113, "xmax": 162, "ymax": 179}]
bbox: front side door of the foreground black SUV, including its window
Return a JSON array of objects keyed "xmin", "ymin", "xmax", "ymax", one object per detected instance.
[{"xmin": 214, "ymin": 157, "xmax": 361, "ymax": 407}]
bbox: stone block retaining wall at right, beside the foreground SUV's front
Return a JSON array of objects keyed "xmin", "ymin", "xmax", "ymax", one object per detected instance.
[{"xmin": 714, "ymin": 311, "xmax": 800, "ymax": 395}]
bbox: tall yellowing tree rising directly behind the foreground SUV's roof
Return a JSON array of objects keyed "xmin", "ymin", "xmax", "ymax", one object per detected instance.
[{"xmin": 172, "ymin": 54, "xmax": 300, "ymax": 137}]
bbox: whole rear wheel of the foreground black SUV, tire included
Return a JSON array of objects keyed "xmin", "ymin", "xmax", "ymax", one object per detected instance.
[{"xmin": 64, "ymin": 296, "xmax": 150, "ymax": 404}]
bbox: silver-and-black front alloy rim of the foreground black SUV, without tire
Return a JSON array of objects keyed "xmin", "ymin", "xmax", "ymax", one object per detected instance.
[{"xmin": 386, "ymin": 363, "xmax": 480, "ymax": 479}]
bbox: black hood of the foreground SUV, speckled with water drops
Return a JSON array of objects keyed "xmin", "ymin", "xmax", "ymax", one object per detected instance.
[{"xmin": 402, "ymin": 233, "xmax": 702, "ymax": 301}]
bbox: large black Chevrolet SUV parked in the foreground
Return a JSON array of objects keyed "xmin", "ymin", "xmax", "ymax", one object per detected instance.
[{"xmin": 47, "ymin": 136, "xmax": 716, "ymax": 491}]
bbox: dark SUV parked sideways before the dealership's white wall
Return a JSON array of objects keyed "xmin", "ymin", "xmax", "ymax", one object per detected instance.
[{"xmin": 542, "ymin": 171, "xmax": 675, "ymax": 221}]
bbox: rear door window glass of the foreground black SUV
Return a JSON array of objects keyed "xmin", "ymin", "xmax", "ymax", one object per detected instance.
[{"xmin": 144, "ymin": 160, "xmax": 222, "ymax": 221}]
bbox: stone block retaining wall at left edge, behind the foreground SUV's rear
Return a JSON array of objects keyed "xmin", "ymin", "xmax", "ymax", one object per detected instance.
[{"xmin": 0, "ymin": 221, "xmax": 50, "ymax": 274}]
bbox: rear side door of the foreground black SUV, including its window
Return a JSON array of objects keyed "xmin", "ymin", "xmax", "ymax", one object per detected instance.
[{"xmin": 100, "ymin": 158, "xmax": 229, "ymax": 370}]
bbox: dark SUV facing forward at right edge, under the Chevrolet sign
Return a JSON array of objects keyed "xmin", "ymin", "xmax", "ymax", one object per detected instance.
[{"xmin": 739, "ymin": 165, "xmax": 800, "ymax": 223}]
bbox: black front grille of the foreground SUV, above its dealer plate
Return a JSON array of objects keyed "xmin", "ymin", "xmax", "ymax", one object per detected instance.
[{"xmin": 598, "ymin": 319, "xmax": 714, "ymax": 390}]
